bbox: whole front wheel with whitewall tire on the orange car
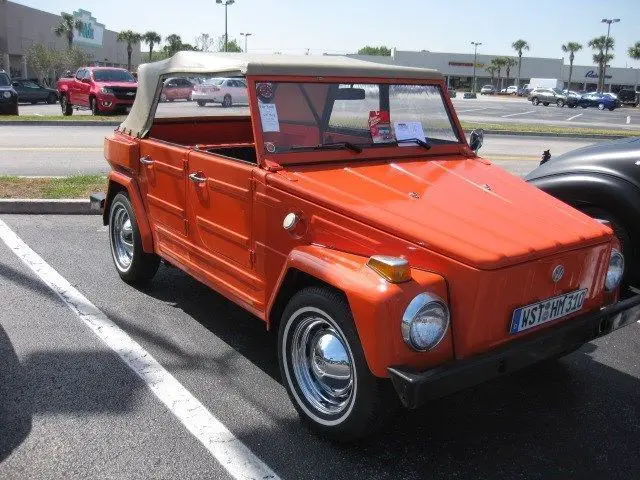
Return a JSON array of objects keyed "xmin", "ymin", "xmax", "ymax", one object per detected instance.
[{"xmin": 278, "ymin": 287, "xmax": 384, "ymax": 442}]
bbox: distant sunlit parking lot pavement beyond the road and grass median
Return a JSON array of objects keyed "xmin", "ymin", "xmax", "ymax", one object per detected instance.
[{"xmin": 15, "ymin": 95, "xmax": 640, "ymax": 130}]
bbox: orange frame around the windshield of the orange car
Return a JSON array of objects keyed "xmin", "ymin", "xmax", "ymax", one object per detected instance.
[{"xmin": 247, "ymin": 76, "xmax": 469, "ymax": 165}]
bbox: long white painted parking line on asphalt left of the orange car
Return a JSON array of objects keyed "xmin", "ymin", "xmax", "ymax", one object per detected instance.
[{"xmin": 0, "ymin": 220, "xmax": 279, "ymax": 480}]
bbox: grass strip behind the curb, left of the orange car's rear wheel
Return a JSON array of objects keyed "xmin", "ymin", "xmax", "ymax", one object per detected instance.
[{"xmin": 0, "ymin": 175, "xmax": 107, "ymax": 198}]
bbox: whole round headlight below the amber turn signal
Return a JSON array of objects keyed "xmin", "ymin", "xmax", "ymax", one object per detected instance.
[{"xmin": 402, "ymin": 293, "xmax": 449, "ymax": 352}]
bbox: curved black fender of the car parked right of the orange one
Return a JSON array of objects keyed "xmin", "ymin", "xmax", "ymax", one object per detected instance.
[{"xmin": 529, "ymin": 172, "xmax": 640, "ymax": 240}]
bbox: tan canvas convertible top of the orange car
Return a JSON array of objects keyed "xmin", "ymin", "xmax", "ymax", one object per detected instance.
[{"xmin": 120, "ymin": 52, "xmax": 442, "ymax": 136}]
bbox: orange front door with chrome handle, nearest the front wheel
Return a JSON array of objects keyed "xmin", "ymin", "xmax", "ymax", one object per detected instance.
[{"xmin": 187, "ymin": 150, "xmax": 264, "ymax": 308}]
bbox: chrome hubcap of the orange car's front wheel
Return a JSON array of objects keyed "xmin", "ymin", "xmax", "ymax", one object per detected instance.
[{"xmin": 291, "ymin": 317, "xmax": 353, "ymax": 415}]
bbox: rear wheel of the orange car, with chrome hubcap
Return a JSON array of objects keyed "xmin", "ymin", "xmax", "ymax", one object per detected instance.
[{"xmin": 109, "ymin": 192, "xmax": 160, "ymax": 286}]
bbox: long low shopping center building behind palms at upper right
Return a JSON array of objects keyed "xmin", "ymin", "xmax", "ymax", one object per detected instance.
[{"xmin": 349, "ymin": 49, "xmax": 640, "ymax": 92}]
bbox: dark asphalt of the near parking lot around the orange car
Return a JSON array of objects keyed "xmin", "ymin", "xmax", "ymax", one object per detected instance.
[{"xmin": 0, "ymin": 215, "xmax": 640, "ymax": 479}]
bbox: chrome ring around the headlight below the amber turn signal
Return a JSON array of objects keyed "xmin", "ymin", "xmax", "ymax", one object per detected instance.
[{"xmin": 401, "ymin": 292, "xmax": 451, "ymax": 352}]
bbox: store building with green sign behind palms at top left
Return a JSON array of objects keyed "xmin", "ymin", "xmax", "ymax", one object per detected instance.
[{"xmin": 0, "ymin": 0, "xmax": 140, "ymax": 77}]
